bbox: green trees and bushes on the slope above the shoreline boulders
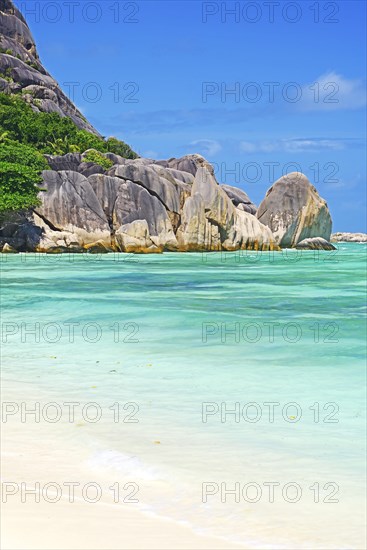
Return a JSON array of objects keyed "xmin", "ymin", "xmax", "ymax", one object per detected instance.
[{"xmin": 0, "ymin": 91, "xmax": 138, "ymax": 217}]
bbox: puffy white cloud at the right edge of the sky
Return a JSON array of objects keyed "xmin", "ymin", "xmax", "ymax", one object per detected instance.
[{"xmin": 296, "ymin": 71, "xmax": 366, "ymax": 111}]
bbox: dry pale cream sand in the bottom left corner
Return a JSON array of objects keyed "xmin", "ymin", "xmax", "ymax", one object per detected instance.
[{"xmin": 1, "ymin": 501, "xmax": 244, "ymax": 550}]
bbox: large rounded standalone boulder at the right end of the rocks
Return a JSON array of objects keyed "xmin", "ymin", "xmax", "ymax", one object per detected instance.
[{"xmin": 256, "ymin": 172, "xmax": 332, "ymax": 247}]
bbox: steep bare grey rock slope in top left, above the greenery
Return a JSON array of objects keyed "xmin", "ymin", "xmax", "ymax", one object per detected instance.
[{"xmin": 0, "ymin": 0, "xmax": 99, "ymax": 135}]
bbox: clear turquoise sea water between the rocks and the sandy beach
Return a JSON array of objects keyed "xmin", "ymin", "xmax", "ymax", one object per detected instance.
[{"xmin": 1, "ymin": 247, "xmax": 366, "ymax": 548}]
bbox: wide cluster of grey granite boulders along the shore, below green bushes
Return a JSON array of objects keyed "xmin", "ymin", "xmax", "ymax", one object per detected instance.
[{"xmin": 0, "ymin": 153, "xmax": 277, "ymax": 253}]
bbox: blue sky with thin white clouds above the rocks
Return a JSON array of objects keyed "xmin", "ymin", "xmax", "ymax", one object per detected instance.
[{"xmin": 16, "ymin": 0, "xmax": 366, "ymax": 231}]
